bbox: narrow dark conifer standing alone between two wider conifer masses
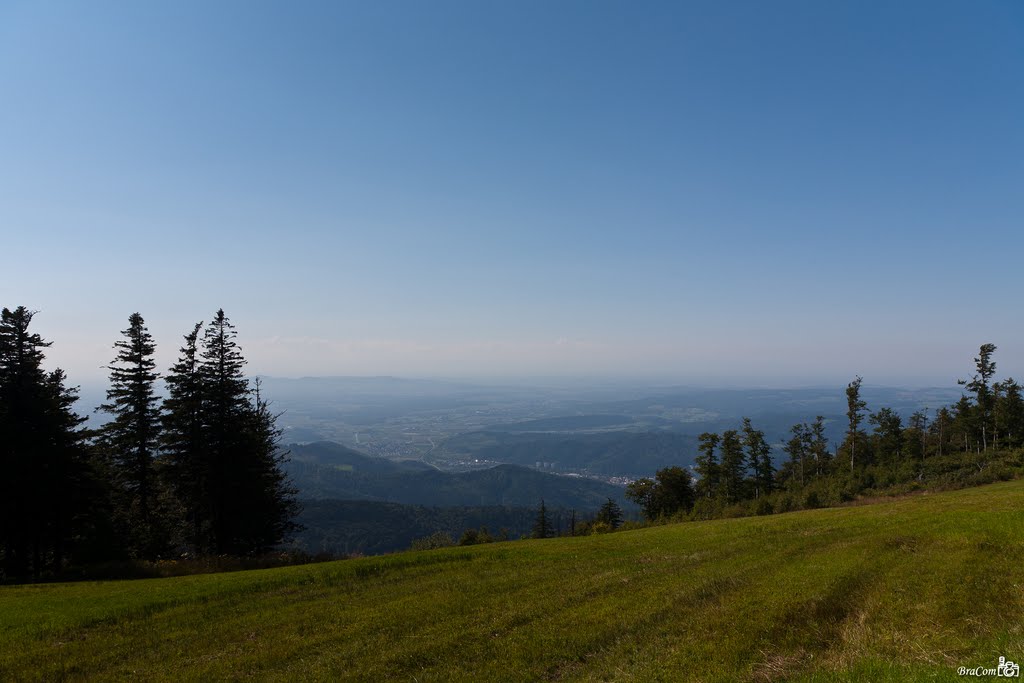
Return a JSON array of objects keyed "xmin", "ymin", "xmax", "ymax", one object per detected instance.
[{"xmin": 97, "ymin": 313, "xmax": 170, "ymax": 559}]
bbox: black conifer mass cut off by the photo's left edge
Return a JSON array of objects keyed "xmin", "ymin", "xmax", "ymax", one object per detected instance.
[{"xmin": 0, "ymin": 306, "xmax": 99, "ymax": 578}]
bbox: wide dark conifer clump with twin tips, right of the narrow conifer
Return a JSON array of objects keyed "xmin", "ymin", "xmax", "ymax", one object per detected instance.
[{"xmin": 159, "ymin": 310, "xmax": 298, "ymax": 555}]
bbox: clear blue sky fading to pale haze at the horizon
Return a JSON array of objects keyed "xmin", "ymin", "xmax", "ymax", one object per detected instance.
[{"xmin": 0, "ymin": 0, "xmax": 1024, "ymax": 385}]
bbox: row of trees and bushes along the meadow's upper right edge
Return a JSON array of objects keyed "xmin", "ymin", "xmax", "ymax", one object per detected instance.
[{"xmin": 627, "ymin": 344, "xmax": 1024, "ymax": 520}]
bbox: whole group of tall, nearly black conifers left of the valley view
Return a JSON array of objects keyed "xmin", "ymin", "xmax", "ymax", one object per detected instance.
[{"xmin": 0, "ymin": 306, "xmax": 298, "ymax": 580}]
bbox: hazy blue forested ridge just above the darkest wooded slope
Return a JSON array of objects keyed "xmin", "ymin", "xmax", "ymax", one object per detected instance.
[{"xmin": 286, "ymin": 441, "xmax": 632, "ymax": 511}]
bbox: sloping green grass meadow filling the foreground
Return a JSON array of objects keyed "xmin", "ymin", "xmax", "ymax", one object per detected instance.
[{"xmin": 0, "ymin": 481, "xmax": 1024, "ymax": 682}]
